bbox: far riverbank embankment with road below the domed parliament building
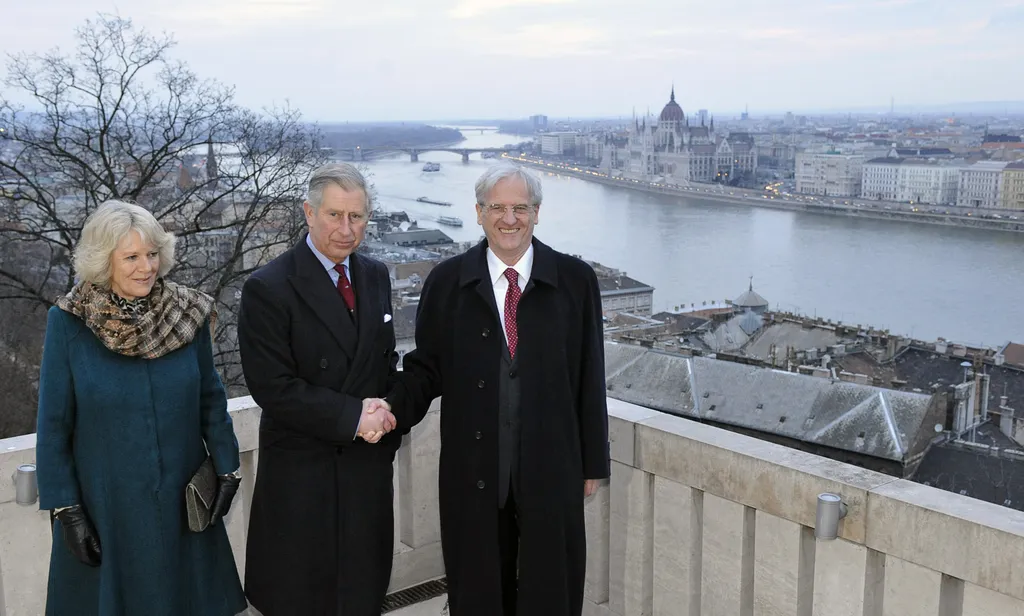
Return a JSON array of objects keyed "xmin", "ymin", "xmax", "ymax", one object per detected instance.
[{"xmin": 508, "ymin": 157, "xmax": 1024, "ymax": 233}]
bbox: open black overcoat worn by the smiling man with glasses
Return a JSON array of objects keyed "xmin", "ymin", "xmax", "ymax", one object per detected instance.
[{"xmin": 389, "ymin": 239, "xmax": 609, "ymax": 616}]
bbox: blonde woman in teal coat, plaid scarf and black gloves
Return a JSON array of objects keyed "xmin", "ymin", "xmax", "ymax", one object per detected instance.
[{"xmin": 37, "ymin": 201, "xmax": 247, "ymax": 616}]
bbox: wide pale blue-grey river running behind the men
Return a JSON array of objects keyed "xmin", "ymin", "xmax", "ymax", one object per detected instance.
[{"xmin": 367, "ymin": 129, "xmax": 1024, "ymax": 346}]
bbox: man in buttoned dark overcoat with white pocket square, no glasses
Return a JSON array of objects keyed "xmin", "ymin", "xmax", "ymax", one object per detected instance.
[{"xmin": 239, "ymin": 164, "xmax": 401, "ymax": 616}]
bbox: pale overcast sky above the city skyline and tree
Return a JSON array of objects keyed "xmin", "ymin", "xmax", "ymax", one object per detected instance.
[{"xmin": 0, "ymin": 0, "xmax": 1024, "ymax": 122}]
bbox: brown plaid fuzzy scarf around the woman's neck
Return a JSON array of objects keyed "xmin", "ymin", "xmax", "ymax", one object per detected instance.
[{"xmin": 56, "ymin": 279, "xmax": 217, "ymax": 359}]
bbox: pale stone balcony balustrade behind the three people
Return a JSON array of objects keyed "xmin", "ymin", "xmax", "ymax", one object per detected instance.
[{"xmin": 0, "ymin": 398, "xmax": 1024, "ymax": 616}]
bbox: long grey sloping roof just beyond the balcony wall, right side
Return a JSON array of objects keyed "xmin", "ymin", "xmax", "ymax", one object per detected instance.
[{"xmin": 605, "ymin": 344, "xmax": 945, "ymax": 463}]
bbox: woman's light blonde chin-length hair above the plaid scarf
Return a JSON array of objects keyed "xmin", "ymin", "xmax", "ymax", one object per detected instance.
[{"xmin": 74, "ymin": 201, "xmax": 175, "ymax": 289}]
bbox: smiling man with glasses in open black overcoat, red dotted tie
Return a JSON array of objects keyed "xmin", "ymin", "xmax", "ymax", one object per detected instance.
[{"xmin": 388, "ymin": 163, "xmax": 609, "ymax": 616}]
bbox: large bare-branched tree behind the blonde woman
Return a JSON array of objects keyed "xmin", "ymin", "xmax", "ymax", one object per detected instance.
[{"xmin": 0, "ymin": 14, "xmax": 327, "ymax": 436}]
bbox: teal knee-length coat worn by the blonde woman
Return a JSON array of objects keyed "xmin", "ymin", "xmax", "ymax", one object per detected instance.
[{"xmin": 36, "ymin": 307, "xmax": 247, "ymax": 616}]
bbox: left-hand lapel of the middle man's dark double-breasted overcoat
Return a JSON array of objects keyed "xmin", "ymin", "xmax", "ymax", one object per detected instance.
[{"xmin": 288, "ymin": 238, "xmax": 356, "ymax": 359}]
